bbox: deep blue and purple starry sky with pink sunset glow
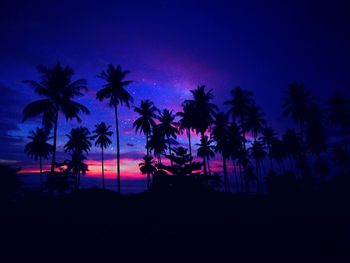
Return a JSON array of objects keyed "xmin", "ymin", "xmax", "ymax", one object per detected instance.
[{"xmin": 0, "ymin": 0, "xmax": 350, "ymax": 186}]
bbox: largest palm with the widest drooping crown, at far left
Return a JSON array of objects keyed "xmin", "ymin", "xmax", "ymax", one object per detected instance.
[{"xmin": 23, "ymin": 62, "xmax": 89, "ymax": 173}]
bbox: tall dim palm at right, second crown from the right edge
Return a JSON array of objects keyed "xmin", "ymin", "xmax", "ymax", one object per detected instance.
[{"xmin": 282, "ymin": 82, "xmax": 312, "ymax": 142}]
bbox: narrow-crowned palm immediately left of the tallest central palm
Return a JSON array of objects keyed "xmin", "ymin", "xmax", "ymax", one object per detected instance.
[{"xmin": 176, "ymin": 102, "xmax": 196, "ymax": 163}]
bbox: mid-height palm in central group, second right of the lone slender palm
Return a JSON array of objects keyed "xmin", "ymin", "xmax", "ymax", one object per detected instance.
[{"xmin": 158, "ymin": 109, "xmax": 179, "ymax": 163}]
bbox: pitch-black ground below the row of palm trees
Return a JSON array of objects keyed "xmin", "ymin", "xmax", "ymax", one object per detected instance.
[{"xmin": 0, "ymin": 190, "xmax": 350, "ymax": 262}]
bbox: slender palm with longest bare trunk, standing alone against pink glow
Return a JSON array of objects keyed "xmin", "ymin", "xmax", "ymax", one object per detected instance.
[{"xmin": 96, "ymin": 64, "xmax": 133, "ymax": 193}]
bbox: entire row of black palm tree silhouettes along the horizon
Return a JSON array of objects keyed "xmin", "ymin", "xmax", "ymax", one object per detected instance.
[{"xmin": 23, "ymin": 63, "xmax": 350, "ymax": 192}]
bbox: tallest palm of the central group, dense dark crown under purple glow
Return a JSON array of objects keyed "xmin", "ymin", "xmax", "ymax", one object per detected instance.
[{"xmin": 184, "ymin": 85, "xmax": 217, "ymax": 176}]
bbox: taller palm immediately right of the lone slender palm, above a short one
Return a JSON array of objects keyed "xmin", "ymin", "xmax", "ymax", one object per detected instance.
[{"xmin": 133, "ymin": 100, "xmax": 158, "ymax": 188}]
